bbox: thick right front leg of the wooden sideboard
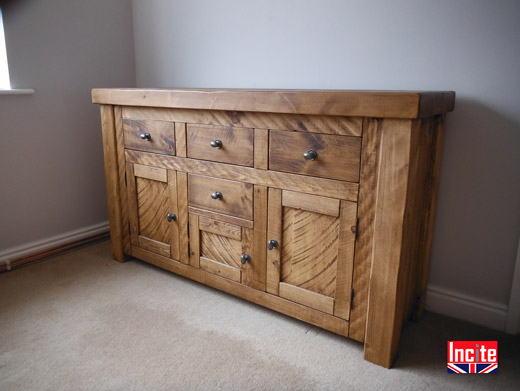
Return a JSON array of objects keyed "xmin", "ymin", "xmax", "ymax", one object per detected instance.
[{"xmin": 365, "ymin": 119, "xmax": 412, "ymax": 368}]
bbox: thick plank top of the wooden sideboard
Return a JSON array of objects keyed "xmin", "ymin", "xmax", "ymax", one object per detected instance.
[{"xmin": 92, "ymin": 88, "xmax": 455, "ymax": 118}]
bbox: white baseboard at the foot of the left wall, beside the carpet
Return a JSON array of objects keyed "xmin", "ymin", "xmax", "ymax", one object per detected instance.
[{"xmin": 0, "ymin": 221, "xmax": 109, "ymax": 272}]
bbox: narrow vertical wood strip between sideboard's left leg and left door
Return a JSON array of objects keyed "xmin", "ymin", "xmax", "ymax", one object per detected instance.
[{"xmin": 114, "ymin": 106, "xmax": 132, "ymax": 255}]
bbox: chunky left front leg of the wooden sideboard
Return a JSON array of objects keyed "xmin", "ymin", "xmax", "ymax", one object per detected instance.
[{"xmin": 101, "ymin": 105, "xmax": 125, "ymax": 262}]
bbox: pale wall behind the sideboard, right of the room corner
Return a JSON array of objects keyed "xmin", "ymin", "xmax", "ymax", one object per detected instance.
[{"xmin": 133, "ymin": 0, "xmax": 520, "ymax": 328}]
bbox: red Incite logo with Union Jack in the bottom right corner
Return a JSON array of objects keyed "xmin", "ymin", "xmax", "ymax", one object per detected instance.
[{"xmin": 448, "ymin": 341, "xmax": 498, "ymax": 373}]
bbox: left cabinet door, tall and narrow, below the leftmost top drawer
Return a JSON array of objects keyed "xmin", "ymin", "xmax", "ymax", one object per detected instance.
[{"xmin": 126, "ymin": 163, "xmax": 179, "ymax": 259}]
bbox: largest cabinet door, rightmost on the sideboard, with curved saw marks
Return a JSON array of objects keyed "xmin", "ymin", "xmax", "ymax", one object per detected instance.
[{"xmin": 267, "ymin": 188, "xmax": 357, "ymax": 320}]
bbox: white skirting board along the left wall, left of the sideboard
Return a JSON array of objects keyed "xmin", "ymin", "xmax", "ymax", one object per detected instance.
[{"xmin": 0, "ymin": 221, "xmax": 109, "ymax": 270}]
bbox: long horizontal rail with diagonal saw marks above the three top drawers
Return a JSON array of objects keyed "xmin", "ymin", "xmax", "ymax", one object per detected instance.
[{"xmin": 123, "ymin": 106, "xmax": 362, "ymax": 137}]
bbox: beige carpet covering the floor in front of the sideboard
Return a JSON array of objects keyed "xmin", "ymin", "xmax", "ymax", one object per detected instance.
[{"xmin": 0, "ymin": 242, "xmax": 520, "ymax": 391}]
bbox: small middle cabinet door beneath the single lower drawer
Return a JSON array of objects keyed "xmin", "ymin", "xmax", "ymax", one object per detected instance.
[{"xmin": 190, "ymin": 213, "xmax": 255, "ymax": 283}]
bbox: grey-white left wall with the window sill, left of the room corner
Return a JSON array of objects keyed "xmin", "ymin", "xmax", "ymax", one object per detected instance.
[{"xmin": 0, "ymin": 0, "xmax": 135, "ymax": 251}]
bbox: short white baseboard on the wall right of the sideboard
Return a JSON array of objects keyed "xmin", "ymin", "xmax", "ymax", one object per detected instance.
[{"xmin": 426, "ymin": 284, "xmax": 507, "ymax": 331}]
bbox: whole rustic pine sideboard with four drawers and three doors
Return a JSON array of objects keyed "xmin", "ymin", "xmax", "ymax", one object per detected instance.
[{"xmin": 92, "ymin": 89, "xmax": 455, "ymax": 367}]
